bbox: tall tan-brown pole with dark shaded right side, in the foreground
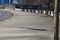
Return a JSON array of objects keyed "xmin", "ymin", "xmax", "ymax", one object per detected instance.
[{"xmin": 54, "ymin": 0, "xmax": 59, "ymax": 40}]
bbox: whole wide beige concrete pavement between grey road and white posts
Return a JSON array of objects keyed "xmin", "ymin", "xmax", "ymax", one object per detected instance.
[{"xmin": 0, "ymin": 9, "xmax": 53, "ymax": 40}]
